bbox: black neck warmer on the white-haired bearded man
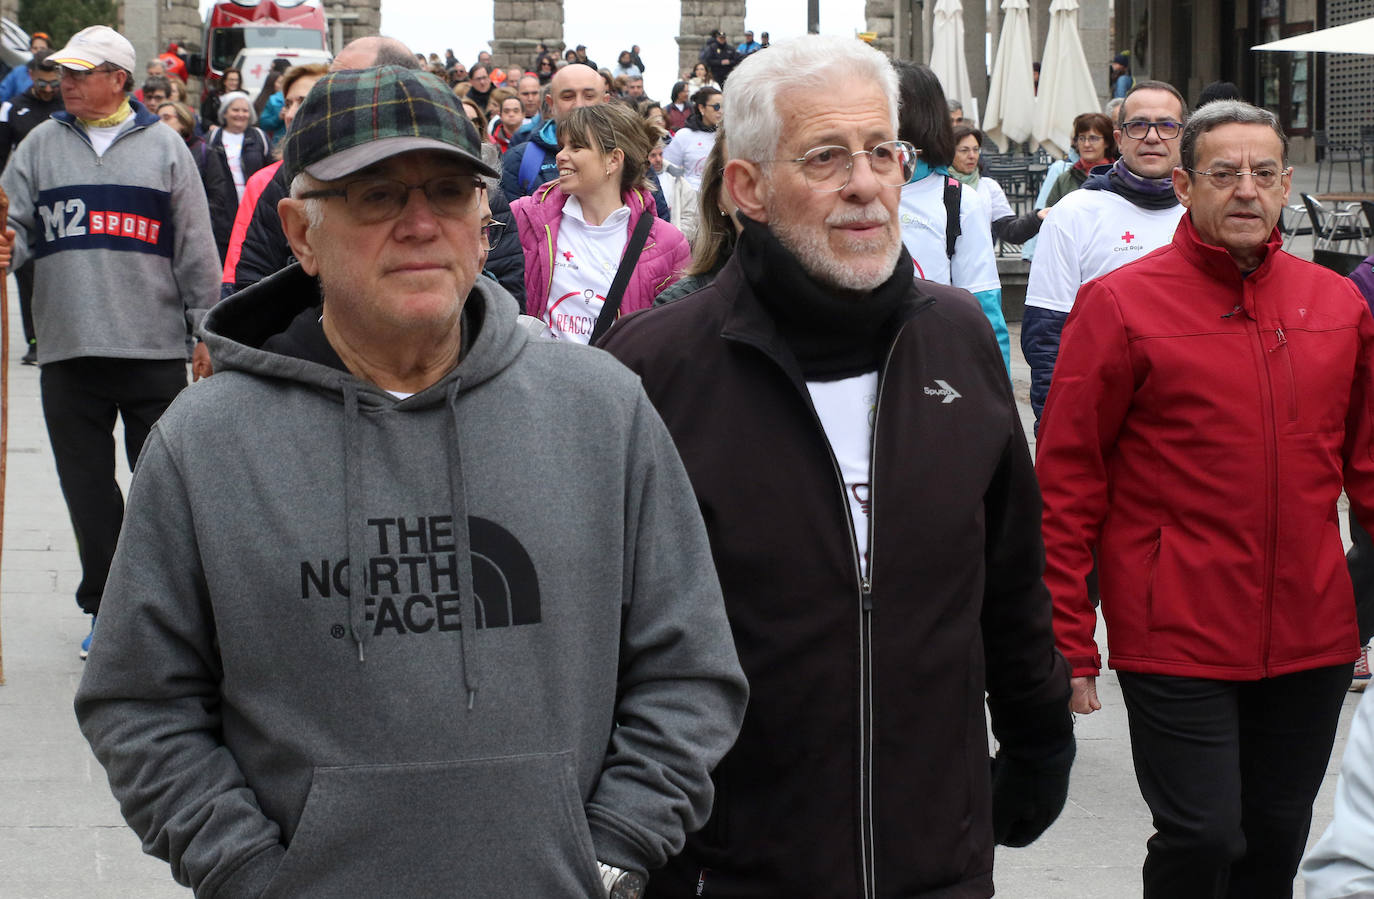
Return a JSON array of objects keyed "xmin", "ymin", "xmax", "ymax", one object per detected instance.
[{"xmin": 735, "ymin": 213, "xmax": 912, "ymax": 381}]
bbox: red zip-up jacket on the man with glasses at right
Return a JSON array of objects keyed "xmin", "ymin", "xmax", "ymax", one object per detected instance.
[{"xmin": 1036, "ymin": 216, "xmax": 1374, "ymax": 680}]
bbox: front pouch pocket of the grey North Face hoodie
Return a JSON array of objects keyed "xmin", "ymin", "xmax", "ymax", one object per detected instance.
[{"xmin": 262, "ymin": 752, "xmax": 605, "ymax": 899}]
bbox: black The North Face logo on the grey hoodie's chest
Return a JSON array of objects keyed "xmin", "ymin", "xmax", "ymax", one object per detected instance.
[{"xmin": 301, "ymin": 515, "xmax": 540, "ymax": 639}]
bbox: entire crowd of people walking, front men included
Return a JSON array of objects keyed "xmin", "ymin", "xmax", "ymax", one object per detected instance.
[{"xmin": 8, "ymin": 19, "xmax": 1374, "ymax": 899}]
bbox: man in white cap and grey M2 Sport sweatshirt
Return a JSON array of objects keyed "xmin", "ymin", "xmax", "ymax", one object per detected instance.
[{"xmin": 0, "ymin": 25, "xmax": 218, "ymax": 658}]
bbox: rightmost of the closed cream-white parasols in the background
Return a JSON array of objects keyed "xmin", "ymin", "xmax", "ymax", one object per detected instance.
[{"xmin": 1031, "ymin": 0, "xmax": 1101, "ymax": 157}]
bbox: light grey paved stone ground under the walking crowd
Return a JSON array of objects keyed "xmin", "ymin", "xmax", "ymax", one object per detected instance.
[{"xmin": 0, "ymin": 163, "xmax": 1358, "ymax": 899}]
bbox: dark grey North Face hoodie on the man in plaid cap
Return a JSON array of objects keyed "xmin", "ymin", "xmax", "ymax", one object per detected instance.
[{"xmin": 76, "ymin": 267, "xmax": 746, "ymax": 896}]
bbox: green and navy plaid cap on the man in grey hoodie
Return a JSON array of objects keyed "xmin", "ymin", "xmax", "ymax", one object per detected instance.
[{"xmin": 282, "ymin": 66, "xmax": 500, "ymax": 181}]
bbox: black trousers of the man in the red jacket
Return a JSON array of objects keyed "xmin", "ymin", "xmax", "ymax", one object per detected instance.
[{"xmin": 1120, "ymin": 665, "xmax": 1351, "ymax": 899}]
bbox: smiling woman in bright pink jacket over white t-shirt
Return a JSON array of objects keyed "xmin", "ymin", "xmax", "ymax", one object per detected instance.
[{"xmin": 511, "ymin": 103, "xmax": 690, "ymax": 344}]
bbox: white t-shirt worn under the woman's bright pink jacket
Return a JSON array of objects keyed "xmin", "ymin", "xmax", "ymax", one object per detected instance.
[{"xmin": 544, "ymin": 197, "xmax": 632, "ymax": 344}]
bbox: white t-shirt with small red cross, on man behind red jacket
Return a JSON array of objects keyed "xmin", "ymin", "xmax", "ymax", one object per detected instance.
[{"xmin": 1026, "ymin": 190, "xmax": 1183, "ymax": 312}]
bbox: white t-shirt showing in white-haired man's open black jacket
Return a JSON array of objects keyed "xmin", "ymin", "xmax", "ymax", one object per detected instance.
[{"xmin": 807, "ymin": 371, "xmax": 878, "ymax": 575}]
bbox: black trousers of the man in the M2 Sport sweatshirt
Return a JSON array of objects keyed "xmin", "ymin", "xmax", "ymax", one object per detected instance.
[{"xmin": 38, "ymin": 356, "xmax": 185, "ymax": 614}]
